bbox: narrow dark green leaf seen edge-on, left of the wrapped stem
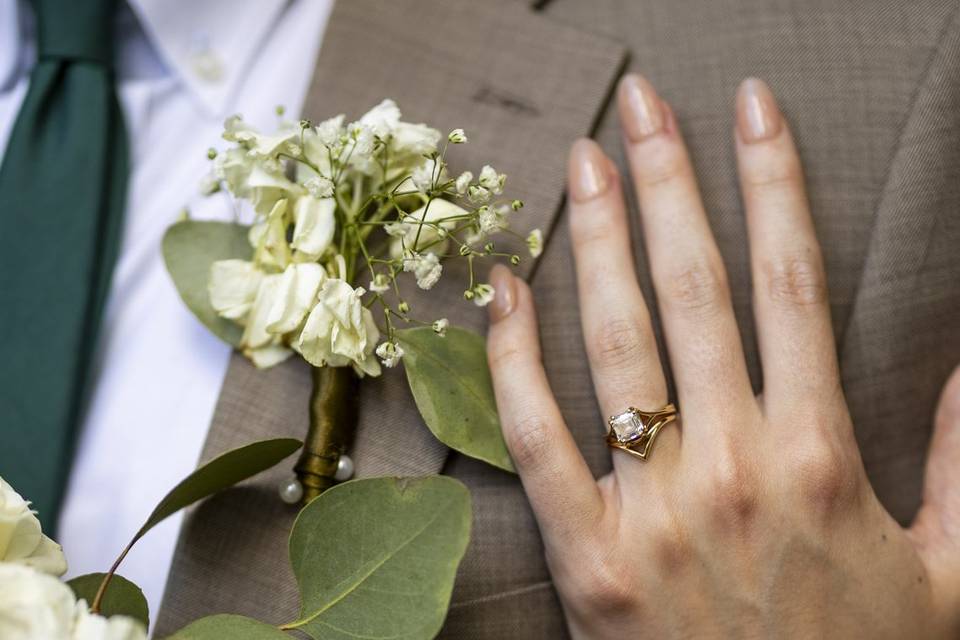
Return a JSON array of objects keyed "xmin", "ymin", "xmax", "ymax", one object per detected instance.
[{"xmin": 130, "ymin": 438, "xmax": 302, "ymax": 545}]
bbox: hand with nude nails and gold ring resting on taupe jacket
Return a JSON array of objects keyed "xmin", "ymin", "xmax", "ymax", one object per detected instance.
[{"xmin": 488, "ymin": 76, "xmax": 960, "ymax": 640}]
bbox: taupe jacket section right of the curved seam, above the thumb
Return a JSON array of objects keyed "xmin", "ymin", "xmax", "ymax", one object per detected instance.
[{"xmin": 841, "ymin": 5, "xmax": 960, "ymax": 524}]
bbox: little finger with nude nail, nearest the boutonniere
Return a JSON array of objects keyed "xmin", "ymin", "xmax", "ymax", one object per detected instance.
[{"xmin": 487, "ymin": 266, "xmax": 602, "ymax": 545}]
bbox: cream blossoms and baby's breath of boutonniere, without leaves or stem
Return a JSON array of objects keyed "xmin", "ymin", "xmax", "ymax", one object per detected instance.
[{"xmin": 203, "ymin": 100, "xmax": 543, "ymax": 375}]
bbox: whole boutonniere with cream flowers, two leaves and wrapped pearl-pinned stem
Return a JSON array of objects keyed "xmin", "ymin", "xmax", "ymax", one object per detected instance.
[{"xmin": 164, "ymin": 100, "xmax": 542, "ymax": 502}]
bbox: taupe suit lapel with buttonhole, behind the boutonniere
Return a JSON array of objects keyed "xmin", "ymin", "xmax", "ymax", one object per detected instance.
[{"xmin": 155, "ymin": 0, "xmax": 623, "ymax": 637}]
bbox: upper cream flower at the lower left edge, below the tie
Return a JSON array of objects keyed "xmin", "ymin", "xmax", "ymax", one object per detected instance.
[{"xmin": 0, "ymin": 478, "xmax": 67, "ymax": 576}]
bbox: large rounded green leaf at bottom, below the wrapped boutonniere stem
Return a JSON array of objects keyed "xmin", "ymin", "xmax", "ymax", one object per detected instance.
[{"xmin": 281, "ymin": 476, "xmax": 471, "ymax": 640}]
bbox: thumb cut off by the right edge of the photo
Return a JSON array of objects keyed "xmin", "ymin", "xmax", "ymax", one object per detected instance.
[{"xmin": 910, "ymin": 367, "xmax": 960, "ymax": 598}]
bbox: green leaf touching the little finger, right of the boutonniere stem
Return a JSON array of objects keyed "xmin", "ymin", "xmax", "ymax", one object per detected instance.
[{"xmin": 397, "ymin": 327, "xmax": 514, "ymax": 471}]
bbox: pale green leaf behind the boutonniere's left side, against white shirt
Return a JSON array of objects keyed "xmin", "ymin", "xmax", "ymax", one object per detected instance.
[{"xmin": 163, "ymin": 220, "xmax": 253, "ymax": 347}]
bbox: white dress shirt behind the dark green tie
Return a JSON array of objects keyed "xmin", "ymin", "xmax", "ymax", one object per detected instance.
[{"xmin": 0, "ymin": 0, "xmax": 332, "ymax": 614}]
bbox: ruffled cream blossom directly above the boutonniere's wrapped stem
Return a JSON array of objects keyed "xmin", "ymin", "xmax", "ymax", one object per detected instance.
[{"xmin": 295, "ymin": 278, "xmax": 380, "ymax": 376}]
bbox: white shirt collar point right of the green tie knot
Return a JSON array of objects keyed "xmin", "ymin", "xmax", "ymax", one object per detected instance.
[{"xmin": 127, "ymin": 0, "xmax": 288, "ymax": 117}]
